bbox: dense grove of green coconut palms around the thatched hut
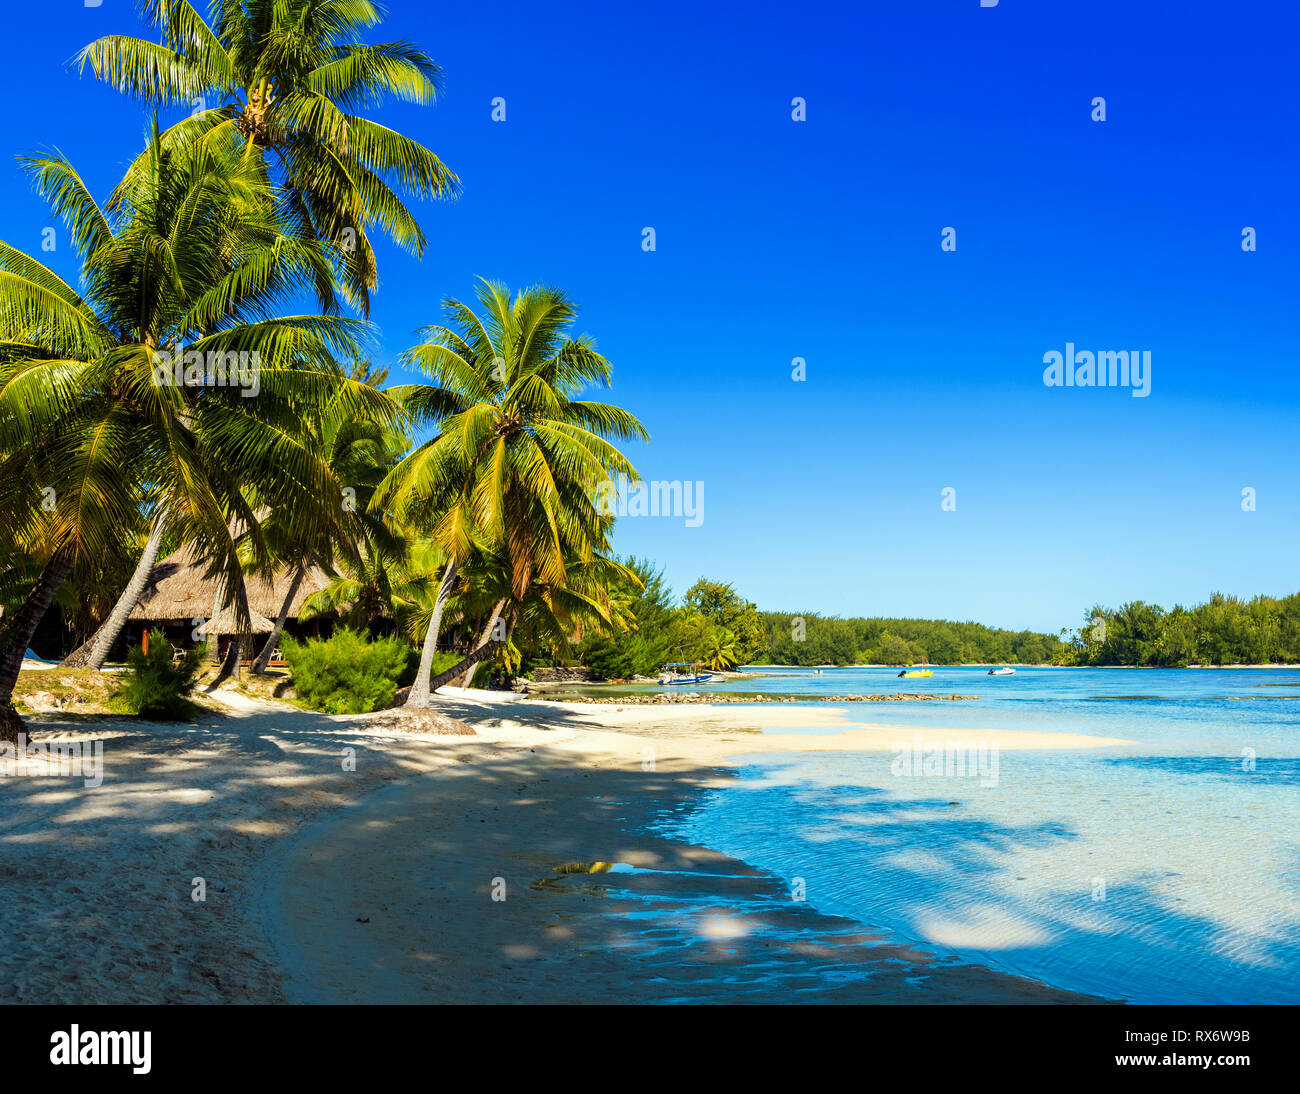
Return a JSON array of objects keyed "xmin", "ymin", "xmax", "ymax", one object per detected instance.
[{"xmin": 0, "ymin": 0, "xmax": 646, "ymax": 737}]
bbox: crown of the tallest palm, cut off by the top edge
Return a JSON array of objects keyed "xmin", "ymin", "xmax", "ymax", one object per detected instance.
[{"xmin": 78, "ymin": 0, "xmax": 459, "ymax": 316}]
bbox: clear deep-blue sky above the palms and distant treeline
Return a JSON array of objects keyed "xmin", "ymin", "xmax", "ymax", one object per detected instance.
[{"xmin": 0, "ymin": 0, "xmax": 1300, "ymax": 630}]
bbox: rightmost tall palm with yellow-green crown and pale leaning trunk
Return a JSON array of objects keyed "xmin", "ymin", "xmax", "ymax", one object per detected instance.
[{"xmin": 373, "ymin": 281, "xmax": 647, "ymax": 706}]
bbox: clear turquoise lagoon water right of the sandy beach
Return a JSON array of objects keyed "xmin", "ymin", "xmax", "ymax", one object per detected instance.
[{"xmin": 655, "ymin": 660, "xmax": 1300, "ymax": 1003}]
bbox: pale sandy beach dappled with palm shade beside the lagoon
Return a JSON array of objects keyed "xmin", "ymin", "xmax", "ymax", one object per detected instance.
[{"xmin": 0, "ymin": 689, "xmax": 1114, "ymax": 1003}]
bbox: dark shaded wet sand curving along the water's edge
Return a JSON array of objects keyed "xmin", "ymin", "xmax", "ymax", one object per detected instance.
[{"xmin": 261, "ymin": 750, "xmax": 1097, "ymax": 1003}]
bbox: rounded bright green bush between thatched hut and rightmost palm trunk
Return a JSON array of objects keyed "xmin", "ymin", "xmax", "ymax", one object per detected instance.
[{"xmin": 281, "ymin": 628, "xmax": 420, "ymax": 715}]
